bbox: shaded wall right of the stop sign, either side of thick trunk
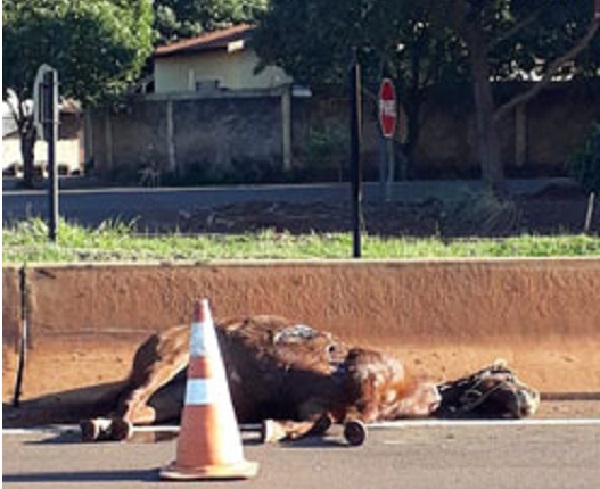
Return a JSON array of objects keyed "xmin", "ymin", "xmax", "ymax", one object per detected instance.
[{"xmin": 416, "ymin": 83, "xmax": 600, "ymax": 176}]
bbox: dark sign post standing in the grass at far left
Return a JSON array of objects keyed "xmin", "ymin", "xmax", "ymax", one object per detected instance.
[{"xmin": 42, "ymin": 70, "xmax": 58, "ymax": 242}]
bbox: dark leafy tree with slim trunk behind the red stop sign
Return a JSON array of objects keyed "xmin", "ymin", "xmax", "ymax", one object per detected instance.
[{"xmin": 253, "ymin": 0, "xmax": 466, "ymax": 173}]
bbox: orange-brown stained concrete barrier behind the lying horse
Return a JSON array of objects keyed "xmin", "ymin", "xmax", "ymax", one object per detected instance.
[{"xmin": 3, "ymin": 259, "xmax": 600, "ymax": 401}]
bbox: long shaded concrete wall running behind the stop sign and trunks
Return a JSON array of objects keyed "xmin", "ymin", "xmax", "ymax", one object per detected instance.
[{"xmin": 88, "ymin": 80, "xmax": 600, "ymax": 184}]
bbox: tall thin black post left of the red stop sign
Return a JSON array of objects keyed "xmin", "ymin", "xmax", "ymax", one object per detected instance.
[{"xmin": 350, "ymin": 58, "xmax": 362, "ymax": 258}]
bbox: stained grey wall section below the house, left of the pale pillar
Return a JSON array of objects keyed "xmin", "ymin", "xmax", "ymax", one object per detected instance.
[{"xmin": 89, "ymin": 90, "xmax": 283, "ymax": 180}]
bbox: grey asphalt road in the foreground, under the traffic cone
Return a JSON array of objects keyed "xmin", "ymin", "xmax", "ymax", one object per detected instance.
[{"xmin": 2, "ymin": 420, "xmax": 600, "ymax": 489}]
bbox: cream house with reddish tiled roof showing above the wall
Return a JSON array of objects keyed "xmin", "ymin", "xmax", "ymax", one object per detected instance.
[{"xmin": 154, "ymin": 25, "xmax": 292, "ymax": 93}]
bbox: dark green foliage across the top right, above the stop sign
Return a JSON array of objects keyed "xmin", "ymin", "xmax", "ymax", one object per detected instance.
[{"xmin": 255, "ymin": 0, "xmax": 600, "ymax": 87}]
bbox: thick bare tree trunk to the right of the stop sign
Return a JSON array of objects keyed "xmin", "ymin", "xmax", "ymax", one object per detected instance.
[{"xmin": 467, "ymin": 28, "xmax": 505, "ymax": 195}]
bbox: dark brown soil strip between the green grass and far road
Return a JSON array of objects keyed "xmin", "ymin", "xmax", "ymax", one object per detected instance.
[{"xmin": 172, "ymin": 191, "xmax": 600, "ymax": 238}]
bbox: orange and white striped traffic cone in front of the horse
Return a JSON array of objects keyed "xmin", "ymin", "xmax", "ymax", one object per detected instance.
[{"xmin": 159, "ymin": 299, "xmax": 258, "ymax": 480}]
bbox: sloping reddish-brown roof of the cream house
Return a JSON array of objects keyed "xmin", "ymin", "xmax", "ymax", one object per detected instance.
[{"xmin": 154, "ymin": 24, "xmax": 254, "ymax": 58}]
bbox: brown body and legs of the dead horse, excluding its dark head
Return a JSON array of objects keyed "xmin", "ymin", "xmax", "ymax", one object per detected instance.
[{"xmin": 81, "ymin": 315, "xmax": 441, "ymax": 444}]
